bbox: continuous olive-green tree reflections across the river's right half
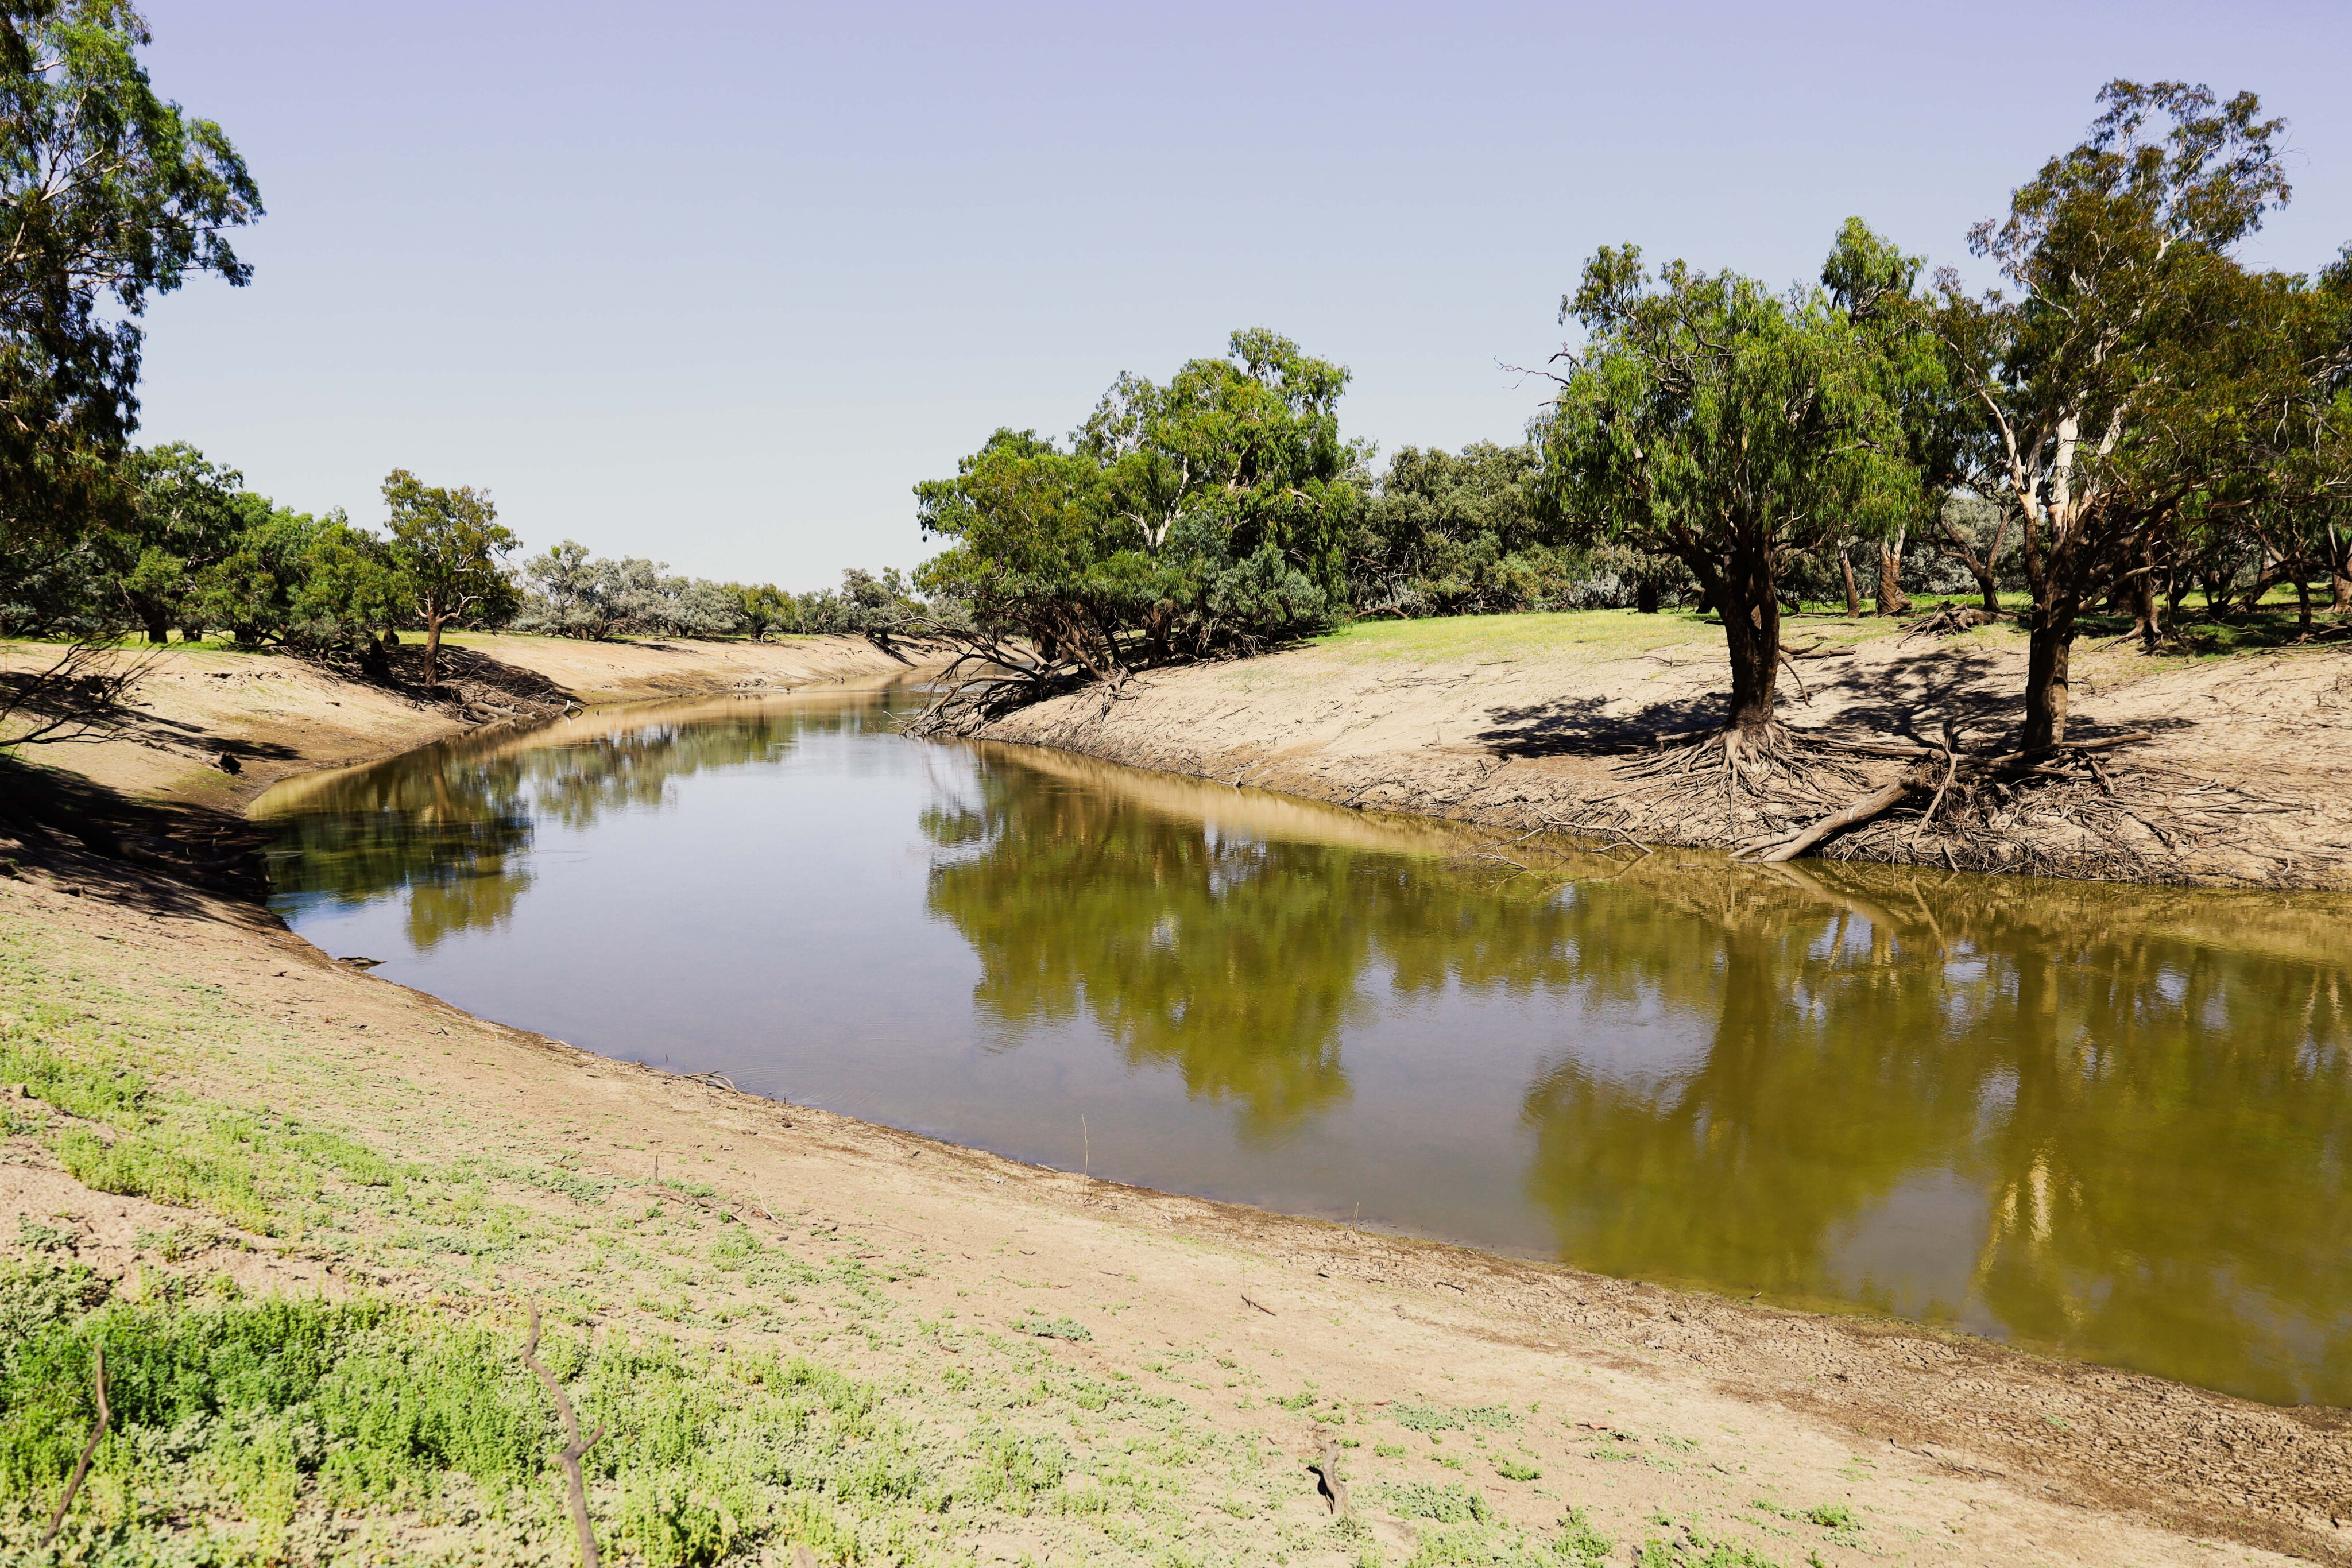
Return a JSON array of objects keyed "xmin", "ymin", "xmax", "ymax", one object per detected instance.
[{"xmin": 924, "ymin": 757, "xmax": 2352, "ymax": 1401}]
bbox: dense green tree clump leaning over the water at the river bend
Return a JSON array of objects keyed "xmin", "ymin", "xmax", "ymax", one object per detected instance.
[{"xmin": 915, "ymin": 329, "xmax": 1364, "ymax": 677}]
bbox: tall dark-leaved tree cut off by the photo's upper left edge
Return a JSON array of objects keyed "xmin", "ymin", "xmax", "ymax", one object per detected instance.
[{"xmin": 0, "ymin": 0, "xmax": 261, "ymax": 597}]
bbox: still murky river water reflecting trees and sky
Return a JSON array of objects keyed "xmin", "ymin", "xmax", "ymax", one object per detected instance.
[{"xmin": 264, "ymin": 694, "xmax": 2352, "ymax": 1403}]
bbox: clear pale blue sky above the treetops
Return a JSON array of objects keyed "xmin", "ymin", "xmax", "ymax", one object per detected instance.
[{"xmin": 144, "ymin": 0, "xmax": 2352, "ymax": 588}]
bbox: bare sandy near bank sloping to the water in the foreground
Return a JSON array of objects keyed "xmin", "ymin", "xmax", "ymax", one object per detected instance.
[{"xmin": 0, "ymin": 858, "xmax": 2352, "ymax": 1568}]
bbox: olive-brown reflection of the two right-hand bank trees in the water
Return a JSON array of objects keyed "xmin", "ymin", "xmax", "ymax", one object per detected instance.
[{"xmin": 1524, "ymin": 868, "xmax": 2352, "ymax": 1401}]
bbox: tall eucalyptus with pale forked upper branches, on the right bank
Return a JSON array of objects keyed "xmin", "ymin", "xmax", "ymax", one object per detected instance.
[{"xmin": 1938, "ymin": 80, "xmax": 2288, "ymax": 752}]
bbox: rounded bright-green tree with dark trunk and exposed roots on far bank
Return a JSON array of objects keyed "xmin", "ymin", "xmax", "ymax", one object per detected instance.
[{"xmin": 1536, "ymin": 223, "xmax": 1917, "ymax": 764}]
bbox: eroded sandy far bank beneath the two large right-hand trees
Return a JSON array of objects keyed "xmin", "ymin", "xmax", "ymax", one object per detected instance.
[{"xmin": 978, "ymin": 611, "xmax": 2352, "ymax": 886}]
